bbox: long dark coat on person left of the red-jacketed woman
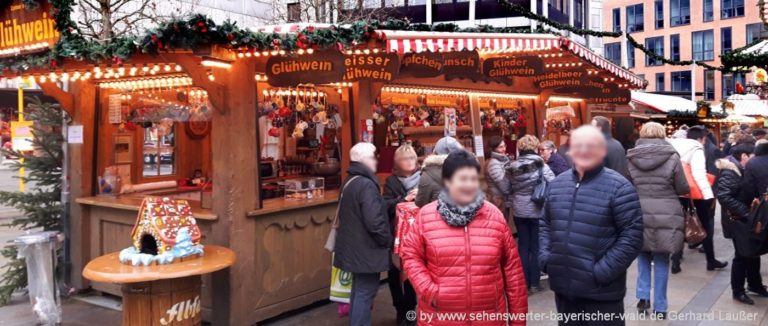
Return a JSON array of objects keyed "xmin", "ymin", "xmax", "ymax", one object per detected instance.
[{"xmin": 333, "ymin": 162, "xmax": 393, "ymax": 273}]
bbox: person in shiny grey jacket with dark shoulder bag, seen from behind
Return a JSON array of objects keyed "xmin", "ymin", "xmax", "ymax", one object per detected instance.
[{"xmin": 507, "ymin": 135, "xmax": 555, "ymax": 292}]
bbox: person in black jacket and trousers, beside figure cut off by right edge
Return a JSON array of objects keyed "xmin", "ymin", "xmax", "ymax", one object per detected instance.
[{"xmin": 715, "ymin": 144, "xmax": 768, "ymax": 305}]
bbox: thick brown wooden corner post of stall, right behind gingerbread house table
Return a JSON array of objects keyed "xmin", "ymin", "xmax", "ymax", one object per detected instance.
[{"xmin": 208, "ymin": 60, "xmax": 262, "ymax": 325}]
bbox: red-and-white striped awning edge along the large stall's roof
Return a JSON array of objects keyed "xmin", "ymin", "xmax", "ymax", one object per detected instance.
[{"xmin": 379, "ymin": 30, "xmax": 645, "ymax": 88}]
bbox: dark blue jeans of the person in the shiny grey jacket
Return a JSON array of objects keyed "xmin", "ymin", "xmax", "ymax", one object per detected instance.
[{"xmin": 515, "ymin": 217, "xmax": 541, "ymax": 288}]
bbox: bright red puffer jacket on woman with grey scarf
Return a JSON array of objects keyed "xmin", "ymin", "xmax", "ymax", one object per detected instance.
[{"xmin": 401, "ymin": 202, "xmax": 528, "ymax": 325}]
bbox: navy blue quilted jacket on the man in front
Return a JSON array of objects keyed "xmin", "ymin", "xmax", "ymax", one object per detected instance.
[{"xmin": 539, "ymin": 167, "xmax": 643, "ymax": 301}]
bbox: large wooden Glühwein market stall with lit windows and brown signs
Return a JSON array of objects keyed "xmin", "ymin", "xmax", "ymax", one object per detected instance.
[{"xmin": 0, "ymin": 2, "xmax": 645, "ymax": 325}]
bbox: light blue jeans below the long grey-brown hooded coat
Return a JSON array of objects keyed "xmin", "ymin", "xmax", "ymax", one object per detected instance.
[{"xmin": 637, "ymin": 252, "xmax": 669, "ymax": 312}]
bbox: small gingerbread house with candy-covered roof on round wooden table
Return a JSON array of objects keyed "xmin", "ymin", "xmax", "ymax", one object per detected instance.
[{"xmin": 131, "ymin": 197, "xmax": 200, "ymax": 255}]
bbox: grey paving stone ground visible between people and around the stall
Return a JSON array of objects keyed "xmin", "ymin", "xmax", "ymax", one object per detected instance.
[{"xmin": 0, "ymin": 208, "xmax": 768, "ymax": 326}]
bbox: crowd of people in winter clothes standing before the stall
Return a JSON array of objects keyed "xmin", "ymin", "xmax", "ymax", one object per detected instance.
[{"xmin": 333, "ymin": 116, "xmax": 768, "ymax": 326}]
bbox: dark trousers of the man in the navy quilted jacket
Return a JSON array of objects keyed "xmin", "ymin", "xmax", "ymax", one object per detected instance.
[{"xmin": 555, "ymin": 293, "xmax": 624, "ymax": 326}]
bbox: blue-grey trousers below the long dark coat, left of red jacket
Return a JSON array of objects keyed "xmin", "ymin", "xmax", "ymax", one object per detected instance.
[{"xmin": 349, "ymin": 273, "xmax": 379, "ymax": 326}]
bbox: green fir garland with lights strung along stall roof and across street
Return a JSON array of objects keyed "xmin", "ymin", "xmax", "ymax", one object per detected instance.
[{"xmin": 0, "ymin": 0, "xmax": 768, "ymax": 74}]
